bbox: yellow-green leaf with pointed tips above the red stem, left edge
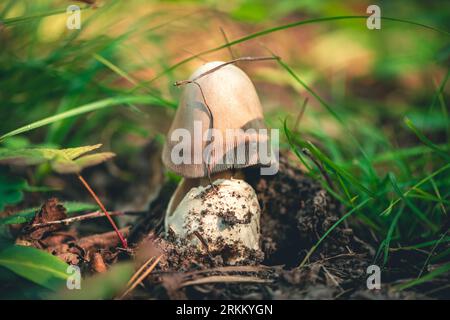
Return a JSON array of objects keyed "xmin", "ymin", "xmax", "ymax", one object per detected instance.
[{"xmin": 0, "ymin": 144, "xmax": 114, "ymax": 174}]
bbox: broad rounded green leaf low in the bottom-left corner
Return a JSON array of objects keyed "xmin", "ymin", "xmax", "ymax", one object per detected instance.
[{"xmin": 0, "ymin": 245, "xmax": 68, "ymax": 290}]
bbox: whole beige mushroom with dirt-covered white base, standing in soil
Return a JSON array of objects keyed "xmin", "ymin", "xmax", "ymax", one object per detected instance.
[{"xmin": 162, "ymin": 61, "xmax": 274, "ymax": 264}]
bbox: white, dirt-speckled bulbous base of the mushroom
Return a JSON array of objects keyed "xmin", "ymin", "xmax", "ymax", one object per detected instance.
[{"xmin": 165, "ymin": 179, "xmax": 262, "ymax": 265}]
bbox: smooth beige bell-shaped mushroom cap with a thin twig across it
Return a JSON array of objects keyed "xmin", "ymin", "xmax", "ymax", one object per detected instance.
[{"xmin": 162, "ymin": 61, "xmax": 270, "ymax": 178}]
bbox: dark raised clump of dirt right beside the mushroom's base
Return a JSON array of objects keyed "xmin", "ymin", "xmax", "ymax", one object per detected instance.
[{"xmin": 247, "ymin": 157, "xmax": 367, "ymax": 267}]
